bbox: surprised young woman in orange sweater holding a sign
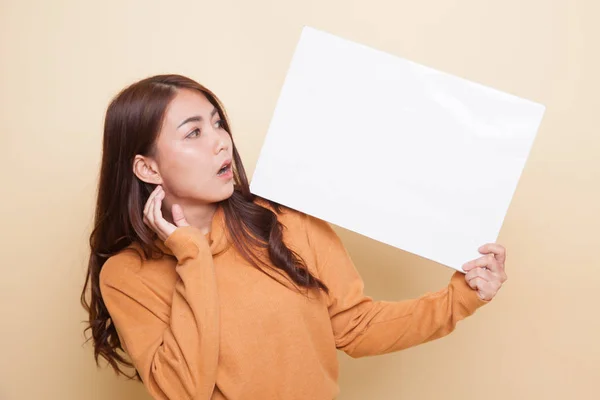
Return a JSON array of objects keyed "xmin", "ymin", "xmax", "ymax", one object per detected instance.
[{"xmin": 82, "ymin": 75, "xmax": 506, "ymax": 400}]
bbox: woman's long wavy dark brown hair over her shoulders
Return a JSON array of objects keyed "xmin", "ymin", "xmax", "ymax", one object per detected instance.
[{"xmin": 81, "ymin": 75, "xmax": 327, "ymax": 378}]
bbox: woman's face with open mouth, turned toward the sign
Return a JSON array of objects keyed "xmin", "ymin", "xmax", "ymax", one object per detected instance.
[{"xmin": 134, "ymin": 89, "xmax": 234, "ymax": 205}]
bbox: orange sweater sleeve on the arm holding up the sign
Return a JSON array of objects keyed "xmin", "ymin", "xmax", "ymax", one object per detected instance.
[{"xmin": 307, "ymin": 216, "xmax": 488, "ymax": 357}]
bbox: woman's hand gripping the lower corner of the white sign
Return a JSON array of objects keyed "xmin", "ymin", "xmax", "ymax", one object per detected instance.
[{"xmin": 463, "ymin": 243, "xmax": 508, "ymax": 301}]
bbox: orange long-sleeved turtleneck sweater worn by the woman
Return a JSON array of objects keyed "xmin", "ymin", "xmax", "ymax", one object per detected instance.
[{"xmin": 100, "ymin": 207, "xmax": 487, "ymax": 400}]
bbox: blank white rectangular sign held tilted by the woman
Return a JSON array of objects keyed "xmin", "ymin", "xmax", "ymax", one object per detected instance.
[{"xmin": 251, "ymin": 27, "xmax": 545, "ymax": 270}]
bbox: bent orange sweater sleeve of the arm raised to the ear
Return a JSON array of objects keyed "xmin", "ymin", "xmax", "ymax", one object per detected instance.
[{"xmin": 100, "ymin": 227, "xmax": 219, "ymax": 400}]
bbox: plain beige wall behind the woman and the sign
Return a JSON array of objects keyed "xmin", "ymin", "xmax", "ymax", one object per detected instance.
[{"xmin": 0, "ymin": 0, "xmax": 600, "ymax": 400}]
